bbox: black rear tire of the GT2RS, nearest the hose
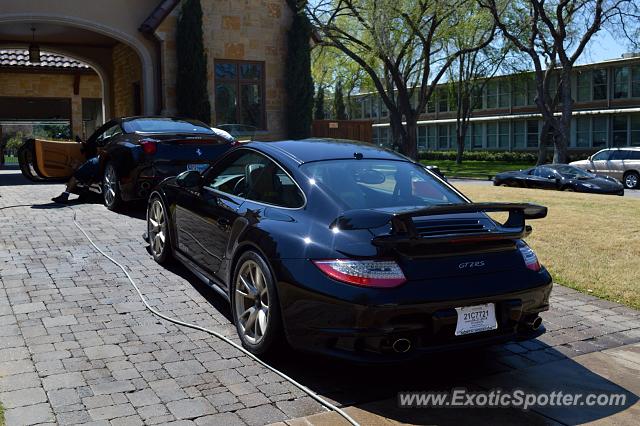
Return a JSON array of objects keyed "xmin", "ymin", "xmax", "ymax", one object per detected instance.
[{"xmin": 229, "ymin": 251, "xmax": 283, "ymax": 355}]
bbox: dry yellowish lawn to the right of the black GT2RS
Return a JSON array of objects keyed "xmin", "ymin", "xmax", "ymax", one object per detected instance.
[{"xmin": 456, "ymin": 183, "xmax": 640, "ymax": 309}]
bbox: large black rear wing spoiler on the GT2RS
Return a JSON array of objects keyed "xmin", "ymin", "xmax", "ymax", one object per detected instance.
[{"xmin": 331, "ymin": 203, "xmax": 547, "ymax": 246}]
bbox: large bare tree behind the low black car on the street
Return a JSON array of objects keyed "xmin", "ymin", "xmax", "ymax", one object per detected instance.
[{"xmin": 477, "ymin": 0, "xmax": 640, "ymax": 163}]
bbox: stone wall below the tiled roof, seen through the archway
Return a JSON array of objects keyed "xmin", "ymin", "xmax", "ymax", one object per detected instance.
[{"xmin": 0, "ymin": 72, "xmax": 102, "ymax": 136}]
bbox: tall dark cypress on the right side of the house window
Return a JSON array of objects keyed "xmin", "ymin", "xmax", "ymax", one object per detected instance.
[{"xmin": 285, "ymin": 0, "xmax": 313, "ymax": 139}]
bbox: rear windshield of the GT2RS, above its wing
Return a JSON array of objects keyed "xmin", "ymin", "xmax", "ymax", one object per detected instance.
[{"xmin": 300, "ymin": 159, "xmax": 465, "ymax": 209}]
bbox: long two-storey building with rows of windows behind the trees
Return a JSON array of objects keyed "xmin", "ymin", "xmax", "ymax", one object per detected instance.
[{"xmin": 350, "ymin": 55, "xmax": 640, "ymax": 152}]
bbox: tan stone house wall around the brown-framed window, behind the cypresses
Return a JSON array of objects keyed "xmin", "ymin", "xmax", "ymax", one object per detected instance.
[{"xmin": 156, "ymin": 0, "xmax": 292, "ymax": 140}]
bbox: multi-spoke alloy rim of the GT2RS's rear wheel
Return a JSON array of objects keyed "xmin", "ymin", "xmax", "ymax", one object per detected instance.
[{"xmin": 234, "ymin": 260, "xmax": 269, "ymax": 345}]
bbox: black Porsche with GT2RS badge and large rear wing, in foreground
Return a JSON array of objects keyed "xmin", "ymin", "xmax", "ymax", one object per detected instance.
[{"xmin": 146, "ymin": 139, "xmax": 552, "ymax": 362}]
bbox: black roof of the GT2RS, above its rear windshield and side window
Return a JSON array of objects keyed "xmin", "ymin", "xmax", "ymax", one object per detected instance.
[{"xmin": 246, "ymin": 138, "xmax": 411, "ymax": 164}]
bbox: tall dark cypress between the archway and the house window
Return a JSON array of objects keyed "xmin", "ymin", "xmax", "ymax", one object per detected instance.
[{"xmin": 176, "ymin": 0, "xmax": 211, "ymax": 123}]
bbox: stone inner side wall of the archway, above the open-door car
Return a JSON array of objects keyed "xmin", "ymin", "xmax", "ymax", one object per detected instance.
[{"xmin": 112, "ymin": 43, "xmax": 144, "ymax": 117}]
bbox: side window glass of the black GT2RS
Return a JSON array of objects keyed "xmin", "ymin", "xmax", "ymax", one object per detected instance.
[{"xmin": 205, "ymin": 150, "xmax": 304, "ymax": 208}]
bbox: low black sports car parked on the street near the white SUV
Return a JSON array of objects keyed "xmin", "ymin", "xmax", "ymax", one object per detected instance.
[{"xmin": 493, "ymin": 164, "xmax": 624, "ymax": 195}]
